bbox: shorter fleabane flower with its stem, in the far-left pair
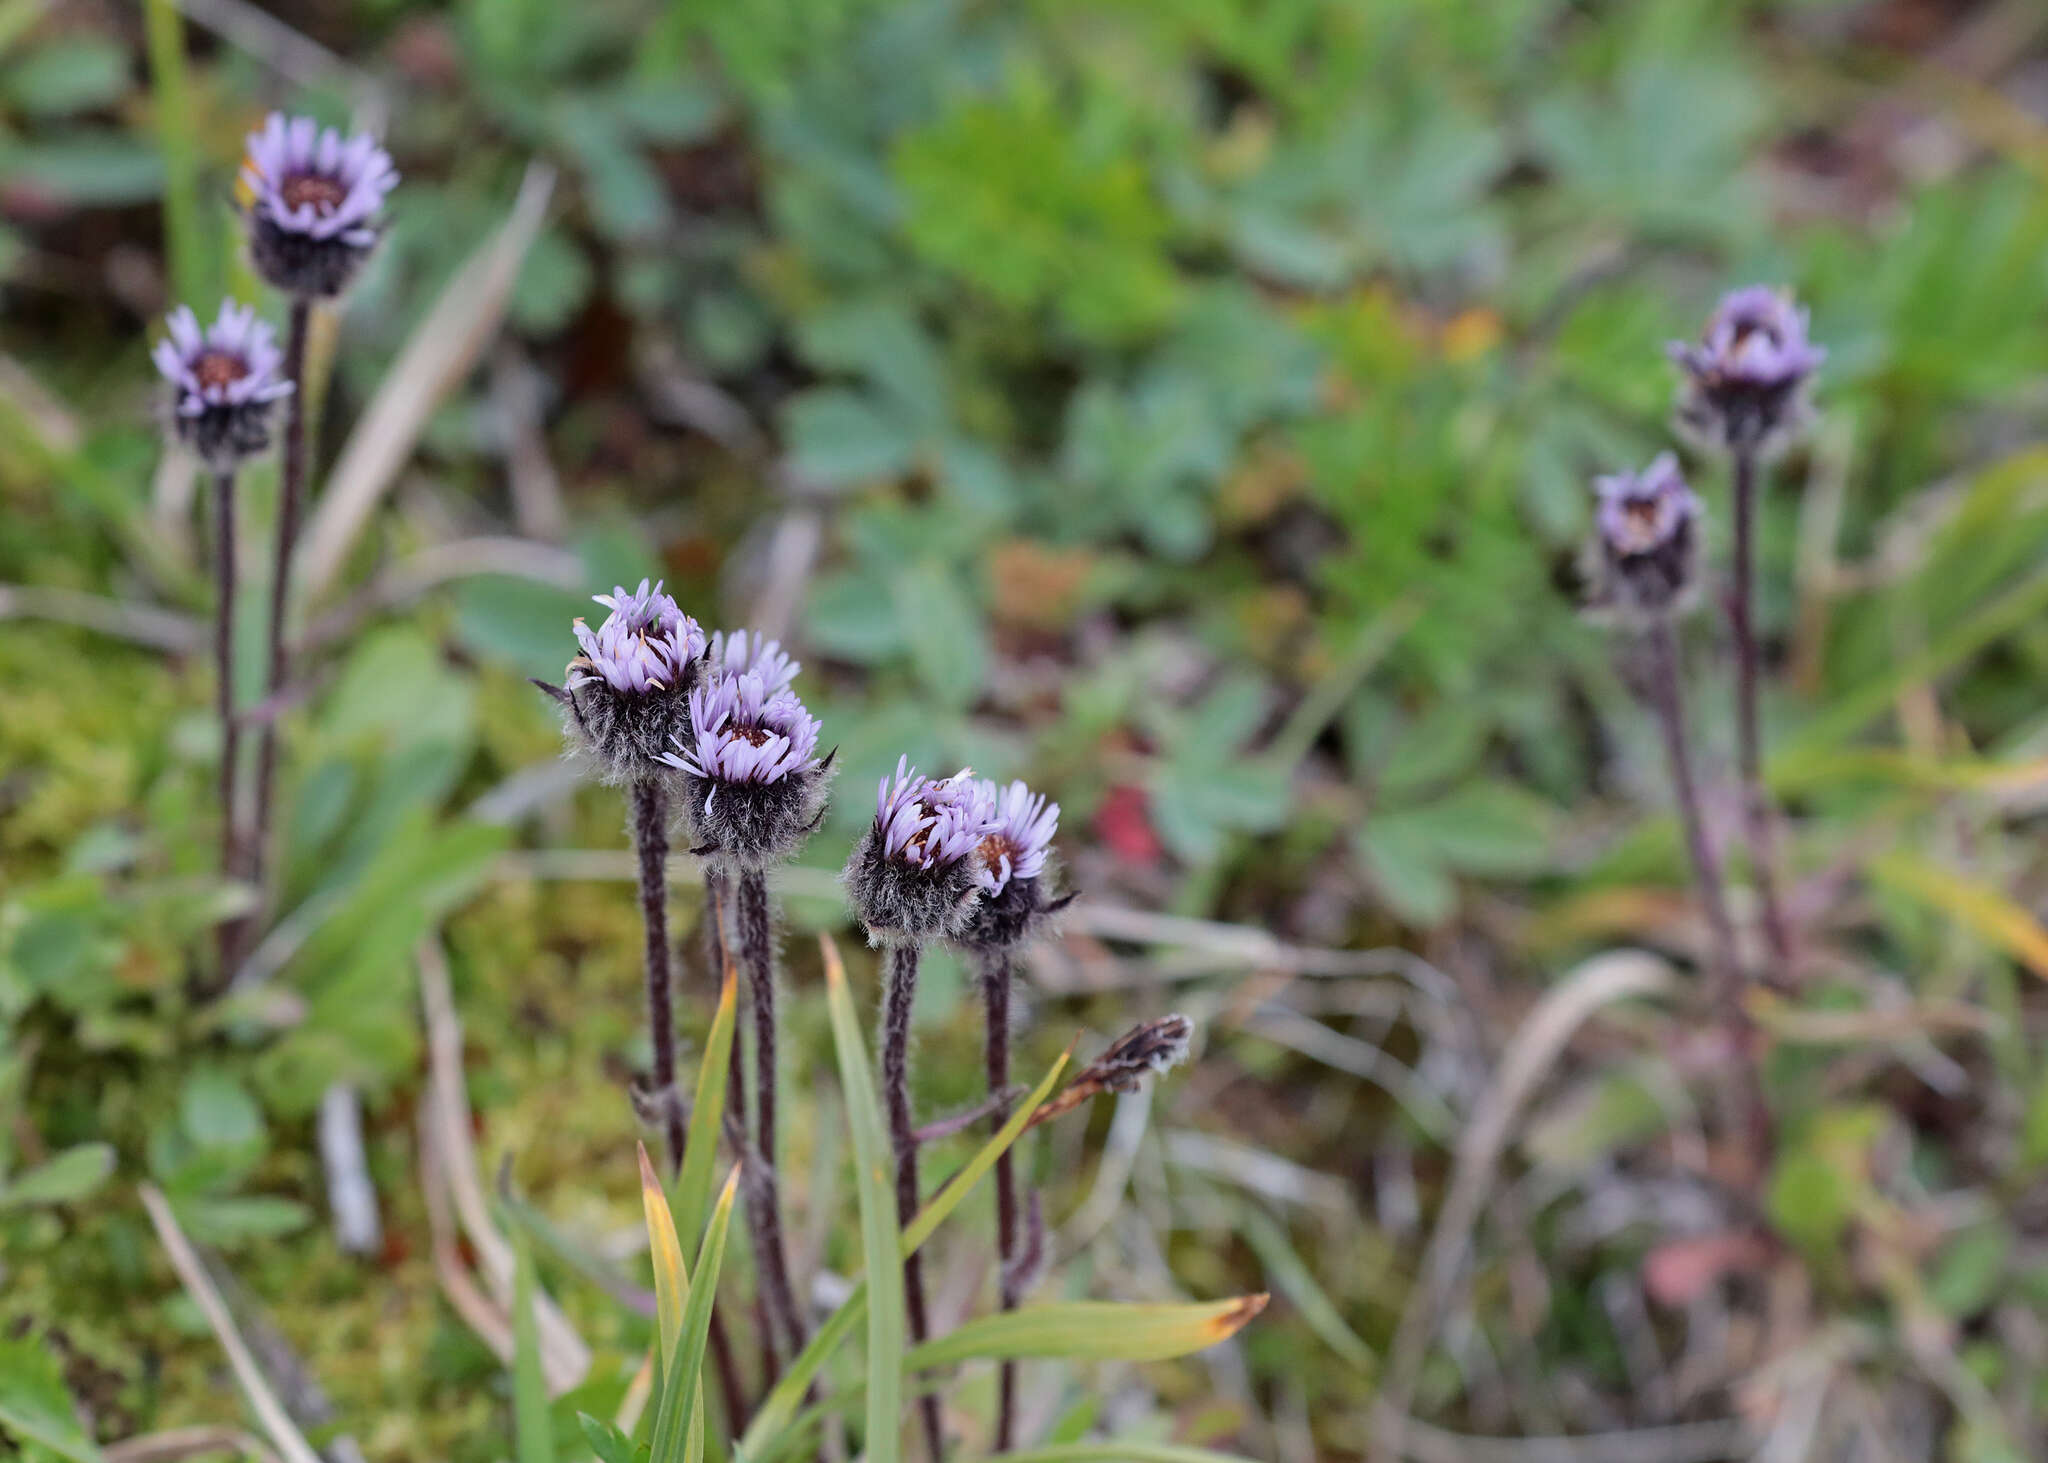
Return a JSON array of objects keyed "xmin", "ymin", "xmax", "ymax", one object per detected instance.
[{"xmin": 152, "ymin": 299, "xmax": 293, "ymax": 958}]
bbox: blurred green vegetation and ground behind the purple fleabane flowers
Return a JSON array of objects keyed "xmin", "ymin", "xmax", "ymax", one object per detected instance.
[{"xmin": 12, "ymin": 0, "xmax": 2048, "ymax": 1463}]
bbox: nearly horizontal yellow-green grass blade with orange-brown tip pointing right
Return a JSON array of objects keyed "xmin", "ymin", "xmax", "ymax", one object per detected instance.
[{"xmin": 903, "ymin": 1295, "xmax": 1266, "ymax": 1371}]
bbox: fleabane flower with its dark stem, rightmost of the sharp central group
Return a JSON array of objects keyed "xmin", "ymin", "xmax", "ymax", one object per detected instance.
[{"xmin": 956, "ymin": 779, "xmax": 1073, "ymax": 1453}]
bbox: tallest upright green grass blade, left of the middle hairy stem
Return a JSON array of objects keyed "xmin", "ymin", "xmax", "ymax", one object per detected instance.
[{"xmin": 819, "ymin": 936, "xmax": 905, "ymax": 1463}]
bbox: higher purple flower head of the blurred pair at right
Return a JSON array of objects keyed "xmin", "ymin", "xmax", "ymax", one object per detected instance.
[{"xmin": 1667, "ymin": 285, "xmax": 1827, "ymax": 451}]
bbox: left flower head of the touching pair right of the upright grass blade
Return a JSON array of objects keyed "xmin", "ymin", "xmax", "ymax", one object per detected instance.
[{"xmin": 846, "ymin": 758, "xmax": 999, "ymax": 945}]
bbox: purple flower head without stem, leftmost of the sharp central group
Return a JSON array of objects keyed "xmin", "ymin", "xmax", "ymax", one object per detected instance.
[{"xmin": 535, "ymin": 580, "xmax": 705, "ymax": 783}]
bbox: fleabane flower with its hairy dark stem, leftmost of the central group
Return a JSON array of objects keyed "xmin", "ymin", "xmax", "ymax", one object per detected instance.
[{"xmin": 535, "ymin": 580, "xmax": 705, "ymax": 1168}]
